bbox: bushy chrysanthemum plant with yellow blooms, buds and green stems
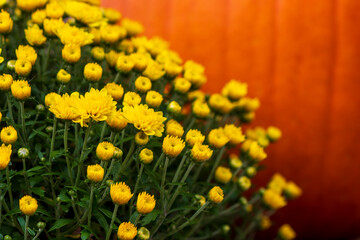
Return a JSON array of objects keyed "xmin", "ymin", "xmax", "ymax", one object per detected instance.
[{"xmin": 0, "ymin": 0, "xmax": 302, "ymax": 240}]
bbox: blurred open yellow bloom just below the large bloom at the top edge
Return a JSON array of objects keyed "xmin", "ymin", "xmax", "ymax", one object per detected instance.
[{"xmin": 55, "ymin": 23, "xmax": 94, "ymax": 47}]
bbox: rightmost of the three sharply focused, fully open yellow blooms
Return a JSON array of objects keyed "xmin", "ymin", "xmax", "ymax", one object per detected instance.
[{"xmin": 123, "ymin": 104, "xmax": 166, "ymax": 137}]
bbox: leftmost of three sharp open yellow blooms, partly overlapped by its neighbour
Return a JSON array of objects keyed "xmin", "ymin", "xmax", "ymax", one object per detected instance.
[{"xmin": 45, "ymin": 92, "xmax": 79, "ymax": 120}]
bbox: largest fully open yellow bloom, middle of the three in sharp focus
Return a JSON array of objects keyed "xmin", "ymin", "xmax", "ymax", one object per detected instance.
[{"xmin": 72, "ymin": 88, "xmax": 116, "ymax": 127}]
